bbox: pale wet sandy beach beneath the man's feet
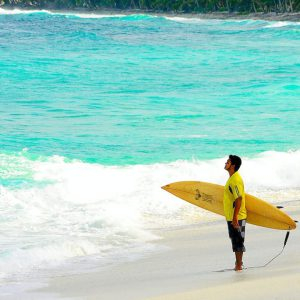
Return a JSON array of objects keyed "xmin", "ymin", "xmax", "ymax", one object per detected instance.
[{"xmin": 14, "ymin": 201, "xmax": 300, "ymax": 300}]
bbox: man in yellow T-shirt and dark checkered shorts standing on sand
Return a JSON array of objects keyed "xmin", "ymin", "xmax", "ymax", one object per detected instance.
[{"xmin": 223, "ymin": 155, "xmax": 247, "ymax": 271}]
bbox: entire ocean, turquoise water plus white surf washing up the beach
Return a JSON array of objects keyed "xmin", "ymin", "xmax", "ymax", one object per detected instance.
[{"xmin": 0, "ymin": 9, "xmax": 300, "ymax": 284}]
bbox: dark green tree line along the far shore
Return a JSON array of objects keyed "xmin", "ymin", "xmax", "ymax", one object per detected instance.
[{"xmin": 0, "ymin": 0, "xmax": 300, "ymax": 13}]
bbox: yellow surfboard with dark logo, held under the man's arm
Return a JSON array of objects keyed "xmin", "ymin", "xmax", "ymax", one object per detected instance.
[{"xmin": 162, "ymin": 181, "xmax": 296, "ymax": 230}]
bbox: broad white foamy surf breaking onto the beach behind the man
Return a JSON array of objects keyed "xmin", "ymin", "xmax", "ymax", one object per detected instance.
[{"xmin": 0, "ymin": 151, "xmax": 300, "ymax": 278}]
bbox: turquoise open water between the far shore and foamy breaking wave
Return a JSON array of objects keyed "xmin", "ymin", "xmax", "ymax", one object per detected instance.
[{"xmin": 0, "ymin": 10, "xmax": 300, "ymax": 165}]
